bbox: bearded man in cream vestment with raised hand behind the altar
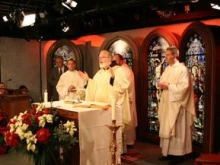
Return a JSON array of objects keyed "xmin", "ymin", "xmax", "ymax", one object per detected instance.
[{"xmin": 80, "ymin": 50, "xmax": 131, "ymax": 125}]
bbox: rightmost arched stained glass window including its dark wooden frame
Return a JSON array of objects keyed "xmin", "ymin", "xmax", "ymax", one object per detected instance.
[{"xmin": 180, "ymin": 22, "xmax": 219, "ymax": 152}]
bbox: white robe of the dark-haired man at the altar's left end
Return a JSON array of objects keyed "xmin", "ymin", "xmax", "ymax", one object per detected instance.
[{"xmin": 56, "ymin": 70, "xmax": 85, "ymax": 100}]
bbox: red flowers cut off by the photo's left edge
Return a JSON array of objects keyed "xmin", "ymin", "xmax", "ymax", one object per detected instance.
[{"xmin": 0, "ymin": 110, "xmax": 8, "ymax": 154}]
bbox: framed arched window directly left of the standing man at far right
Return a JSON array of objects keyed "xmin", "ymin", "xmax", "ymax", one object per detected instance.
[{"xmin": 139, "ymin": 28, "xmax": 178, "ymax": 142}]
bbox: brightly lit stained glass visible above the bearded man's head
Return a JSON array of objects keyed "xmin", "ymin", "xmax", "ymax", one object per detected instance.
[{"xmin": 108, "ymin": 39, "xmax": 133, "ymax": 68}]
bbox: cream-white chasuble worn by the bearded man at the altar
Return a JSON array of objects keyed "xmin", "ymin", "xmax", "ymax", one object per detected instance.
[{"xmin": 85, "ymin": 66, "xmax": 131, "ymax": 125}]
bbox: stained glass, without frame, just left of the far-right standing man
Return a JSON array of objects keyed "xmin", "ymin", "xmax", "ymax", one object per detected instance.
[{"xmin": 146, "ymin": 36, "xmax": 169, "ymax": 134}]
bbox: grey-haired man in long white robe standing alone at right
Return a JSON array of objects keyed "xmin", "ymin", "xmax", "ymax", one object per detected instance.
[{"xmin": 157, "ymin": 46, "xmax": 195, "ymax": 164}]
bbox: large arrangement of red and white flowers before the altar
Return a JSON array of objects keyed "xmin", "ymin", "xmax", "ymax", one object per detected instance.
[{"xmin": 5, "ymin": 104, "xmax": 77, "ymax": 165}]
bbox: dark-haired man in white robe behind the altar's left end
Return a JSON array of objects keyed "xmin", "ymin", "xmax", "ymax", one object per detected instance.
[{"xmin": 56, "ymin": 59, "xmax": 85, "ymax": 100}]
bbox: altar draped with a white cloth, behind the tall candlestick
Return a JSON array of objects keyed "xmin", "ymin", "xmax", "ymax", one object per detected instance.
[{"xmin": 39, "ymin": 101, "xmax": 122, "ymax": 165}]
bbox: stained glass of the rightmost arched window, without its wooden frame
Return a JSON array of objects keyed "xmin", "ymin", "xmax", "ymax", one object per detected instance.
[{"xmin": 185, "ymin": 33, "xmax": 206, "ymax": 144}]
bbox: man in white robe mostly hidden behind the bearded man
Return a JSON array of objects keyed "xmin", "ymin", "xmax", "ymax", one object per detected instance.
[{"xmin": 113, "ymin": 54, "xmax": 138, "ymax": 146}]
